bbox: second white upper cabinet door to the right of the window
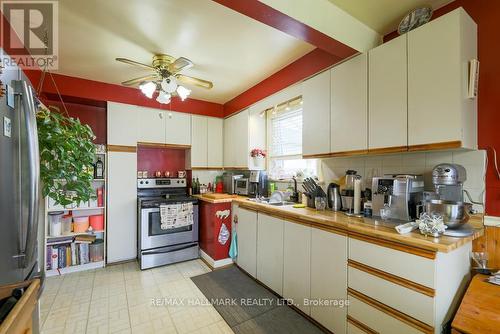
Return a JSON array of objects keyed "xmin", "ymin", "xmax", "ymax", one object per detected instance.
[{"xmin": 330, "ymin": 54, "xmax": 368, "ymax": 152}]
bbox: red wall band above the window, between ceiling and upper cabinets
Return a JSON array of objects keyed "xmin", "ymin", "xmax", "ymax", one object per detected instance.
[{"xmin": 224, "ymin": 49, "xmax": 343, "ymax": 116}]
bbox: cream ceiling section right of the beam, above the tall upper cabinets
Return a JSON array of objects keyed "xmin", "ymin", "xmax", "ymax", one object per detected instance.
[{"xmin": 329, "ymin": 0, "xmax": 452, "ymax": 35}]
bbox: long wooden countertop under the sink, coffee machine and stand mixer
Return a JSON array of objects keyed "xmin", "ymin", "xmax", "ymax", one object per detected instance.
[{"xmin": 234, "ymin": 197, "xmax": 484, "ymax": 253}]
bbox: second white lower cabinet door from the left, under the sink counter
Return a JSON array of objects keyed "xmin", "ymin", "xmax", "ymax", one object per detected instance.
[{"xmin": 257, "ymin": 212, "xmax": 283, "ymax": 296}]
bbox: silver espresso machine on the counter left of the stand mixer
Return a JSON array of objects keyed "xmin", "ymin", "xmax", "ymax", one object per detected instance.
[{"xmin": 372, "ymin": 174, "xmax": 424, "ymax": 221}]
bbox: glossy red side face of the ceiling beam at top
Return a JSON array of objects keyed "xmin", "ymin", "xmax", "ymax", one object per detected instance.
[{"xmin": 213, "ymin": 0, "xmax": 357, "ymax": 59}]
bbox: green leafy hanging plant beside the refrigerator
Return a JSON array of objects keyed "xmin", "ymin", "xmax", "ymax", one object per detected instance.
[{"xmin": 36, "ymin": 107, "xmax": 95, "ymax": 205}]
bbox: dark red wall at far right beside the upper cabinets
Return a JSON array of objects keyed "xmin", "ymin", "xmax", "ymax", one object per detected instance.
[{"xmin": 384, "ymin": 0, "xmax": 500, "ymax": 216}]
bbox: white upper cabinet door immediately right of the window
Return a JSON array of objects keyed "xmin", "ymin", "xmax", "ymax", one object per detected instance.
[{"xmin": 302, "ymin": 71, "xmax": 330, "ymax": 156}]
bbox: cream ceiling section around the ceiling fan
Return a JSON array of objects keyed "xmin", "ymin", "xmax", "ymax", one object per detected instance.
[{"xmin": 57, "ymin": 0, "xmax": 314, "ymax": 103}]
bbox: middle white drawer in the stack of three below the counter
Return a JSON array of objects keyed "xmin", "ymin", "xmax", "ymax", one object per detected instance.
[{"xmin": 348, "ymin": 267, "xmax": 434, "ymax": 325}]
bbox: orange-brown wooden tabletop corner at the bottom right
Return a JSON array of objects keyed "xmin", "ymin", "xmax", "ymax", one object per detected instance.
[{"xmin": 451, "ymin": 274, "xmax": 500, "ymax": 333}]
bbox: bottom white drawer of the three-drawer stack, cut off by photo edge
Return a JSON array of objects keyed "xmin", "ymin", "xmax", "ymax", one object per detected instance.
[{"xmin": 348, "ymin": 296, "xmax": 430, "ymax": 334}]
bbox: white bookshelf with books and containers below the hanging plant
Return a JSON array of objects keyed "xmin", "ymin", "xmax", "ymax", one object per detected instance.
[{"xmin": 43, "ymin": 149, "xmax": 108, "ymax": 277}]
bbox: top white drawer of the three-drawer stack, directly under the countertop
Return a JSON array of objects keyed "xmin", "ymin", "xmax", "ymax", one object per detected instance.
[{"xmin": 349, "ymin": 238, "xmax": 435, "ymax": 288}]
